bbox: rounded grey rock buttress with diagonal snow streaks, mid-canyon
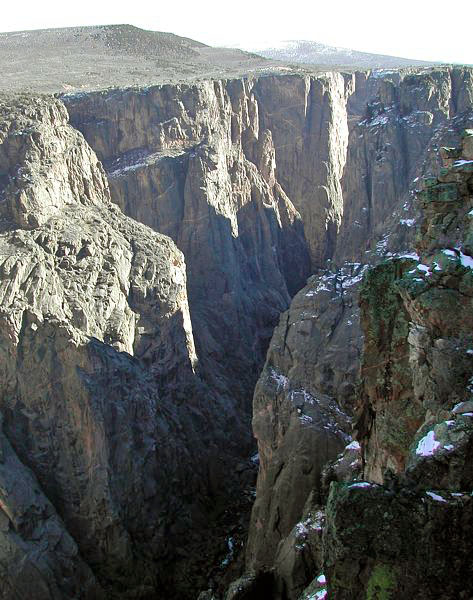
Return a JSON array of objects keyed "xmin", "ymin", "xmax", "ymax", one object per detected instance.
[{"xmin": 247, "ymin": 265, "xmax": 363, "ymax": 569}]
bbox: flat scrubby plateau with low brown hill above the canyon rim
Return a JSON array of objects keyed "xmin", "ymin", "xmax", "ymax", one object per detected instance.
[{"xmin": 0, "ymin": 25, "xmax": 308, "ymax": 93}]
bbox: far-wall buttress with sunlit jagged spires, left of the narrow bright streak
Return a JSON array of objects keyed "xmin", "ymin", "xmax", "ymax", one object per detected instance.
[{"xmin": 66, "ymin": 81, "xmax": 310, "ymax": 413}]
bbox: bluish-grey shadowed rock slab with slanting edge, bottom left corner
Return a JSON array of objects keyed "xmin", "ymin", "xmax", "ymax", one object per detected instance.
[{"xmin": 0, "ymin": 412, "xmax": 105, "ymax": 600}]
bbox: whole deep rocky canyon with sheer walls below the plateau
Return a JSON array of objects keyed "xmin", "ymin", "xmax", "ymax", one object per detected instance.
[{"xmin": 0, "ymin": 27, "xmax": 473, "ymax": 600}]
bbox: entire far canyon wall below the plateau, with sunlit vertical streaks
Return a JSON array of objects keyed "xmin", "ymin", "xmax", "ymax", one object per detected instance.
[{"xmin": 64, "ymin": 69, "xmax": 472, "ymax": 432}]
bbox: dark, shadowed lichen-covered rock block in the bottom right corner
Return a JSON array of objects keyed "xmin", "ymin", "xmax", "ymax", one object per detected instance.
[{"xmin": 324, "ymin": 482, "xmax": 473, "ymax": 600}]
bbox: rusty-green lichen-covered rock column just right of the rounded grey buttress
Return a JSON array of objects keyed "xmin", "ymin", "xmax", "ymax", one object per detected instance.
[{"xmin": 356, "ymin": 259, "xmax": 424, "ymax": 483}]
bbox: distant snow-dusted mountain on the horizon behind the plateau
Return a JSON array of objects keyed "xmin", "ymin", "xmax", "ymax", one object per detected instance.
[{"xmin": 242, "ymin": 40, "xmax": 441, "ymax": 69}]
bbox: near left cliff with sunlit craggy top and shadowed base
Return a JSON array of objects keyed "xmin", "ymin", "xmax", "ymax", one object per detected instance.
[{"xmin": 0, "ymin": 97, "xmax": 251, "ymax": 599}]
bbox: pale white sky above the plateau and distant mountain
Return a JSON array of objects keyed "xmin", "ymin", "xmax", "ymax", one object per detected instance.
[{"xmin": 0, "ymin": 0, "xmax": 473, "ymax": 63}]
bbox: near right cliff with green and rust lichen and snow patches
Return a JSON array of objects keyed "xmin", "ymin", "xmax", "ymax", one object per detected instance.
[{"xmin": 324, "ymin": 130, "xmax": 473, "ymax": 599}]
